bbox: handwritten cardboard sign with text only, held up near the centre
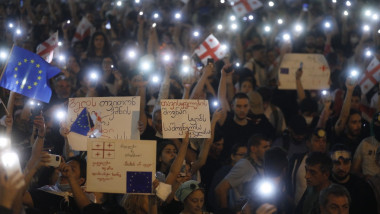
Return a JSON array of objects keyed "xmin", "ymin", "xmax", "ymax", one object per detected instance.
[{"xmin": 161, "ymin": 100, "xmax": 211, "ymax": 138}]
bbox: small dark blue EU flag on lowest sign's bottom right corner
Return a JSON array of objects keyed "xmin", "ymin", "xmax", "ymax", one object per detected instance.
[{"xmin": 127, "ymin": 172, "xmax": 152, "ymax": 193}]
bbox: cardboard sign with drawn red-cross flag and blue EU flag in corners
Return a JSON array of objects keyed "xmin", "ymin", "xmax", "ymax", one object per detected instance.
[{"xmin": 86, "ymin": 138, "xmax": 156, "ymax": 194}]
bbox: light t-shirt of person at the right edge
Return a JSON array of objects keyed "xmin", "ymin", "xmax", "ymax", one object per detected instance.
[{"xmin": 354, "ymin": 136, "xmax": 380, "ymax": 176}]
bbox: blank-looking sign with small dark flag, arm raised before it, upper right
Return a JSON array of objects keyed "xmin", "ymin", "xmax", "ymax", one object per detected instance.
[{"xmin": 278, "ymin": 54, "xmax": 330, "ymax": 90}]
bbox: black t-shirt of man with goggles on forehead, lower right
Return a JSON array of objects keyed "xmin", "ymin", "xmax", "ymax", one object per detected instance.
[{"xmin": 331, "ymin": 174, "xmax": 377, "ymax": 214}]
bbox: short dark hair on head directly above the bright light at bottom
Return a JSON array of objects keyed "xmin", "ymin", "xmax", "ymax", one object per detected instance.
[{"xmin": 264, "ymin": 147, "xmax": 288, "ymax": 177}]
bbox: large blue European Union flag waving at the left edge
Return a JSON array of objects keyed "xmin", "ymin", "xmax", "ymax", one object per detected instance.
[{"xmin": 0, "ymin": 46, "xmax": 60, "ymax": 103}]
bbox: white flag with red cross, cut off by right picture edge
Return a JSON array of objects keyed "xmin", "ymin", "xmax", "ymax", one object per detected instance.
[{"xmin": 359, "ymin": 57, "xmax": 380, "ymax": 94}]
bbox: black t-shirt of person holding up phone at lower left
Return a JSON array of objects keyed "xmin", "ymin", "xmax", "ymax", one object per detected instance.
[{"xmin": 30, "ymin": 189, "xmax": 81, "ymax": 214}]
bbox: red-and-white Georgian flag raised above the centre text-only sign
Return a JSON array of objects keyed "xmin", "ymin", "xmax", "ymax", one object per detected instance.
[{"xmin": 194, "ymin": 34, "xmax": 227, "ymax": 65}]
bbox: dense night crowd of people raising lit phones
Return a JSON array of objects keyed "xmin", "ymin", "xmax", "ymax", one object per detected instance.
[{"xmin": 0, "ymin": 0, "xmax": 380, "ymax": 214}]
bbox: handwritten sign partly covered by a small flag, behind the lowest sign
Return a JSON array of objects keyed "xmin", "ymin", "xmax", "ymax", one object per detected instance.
[{"xmin": 68, "ymin": 97, "xmax": 140, "ymax": 151}]
